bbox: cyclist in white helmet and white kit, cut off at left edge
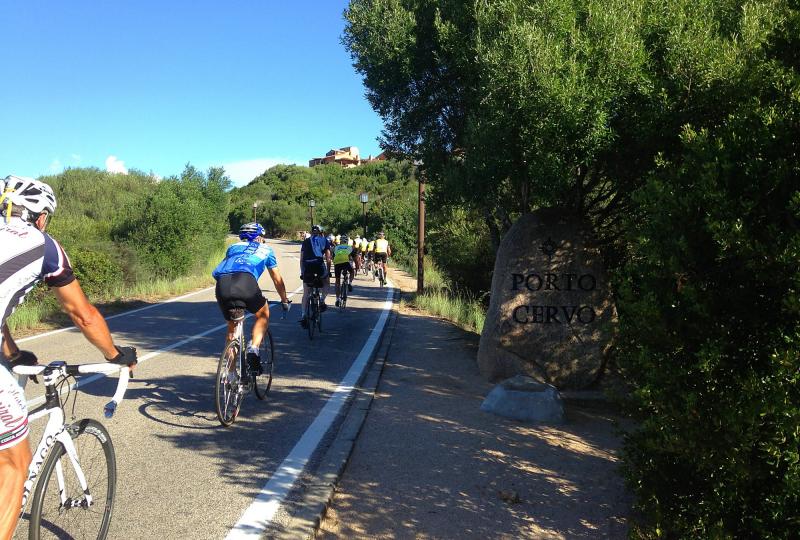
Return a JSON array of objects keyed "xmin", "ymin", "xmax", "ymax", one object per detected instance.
[{"xmin": 0, "ymin": 176, "xmax": 136, "ymax": 538}]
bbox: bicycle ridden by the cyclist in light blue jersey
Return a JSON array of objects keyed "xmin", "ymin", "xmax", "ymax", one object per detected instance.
[{"xmin": 214, "ymin": 308, "xmax": 278, "ymax": 427}]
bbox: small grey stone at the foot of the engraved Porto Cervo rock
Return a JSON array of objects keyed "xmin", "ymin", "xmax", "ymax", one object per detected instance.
[{"xmin": 481, "ymin": 375, "xmax": 564, "ymax": 424}]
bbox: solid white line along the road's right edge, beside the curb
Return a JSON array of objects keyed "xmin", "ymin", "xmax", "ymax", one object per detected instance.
[{"xmin": 225, "ymin": 282, "xmax": 394, "ymax": 540}]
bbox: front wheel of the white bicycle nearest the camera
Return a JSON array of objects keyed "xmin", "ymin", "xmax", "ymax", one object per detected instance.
[{"xmin": 28, "ymin": 418, "xmax": 117, "ymax": 540}]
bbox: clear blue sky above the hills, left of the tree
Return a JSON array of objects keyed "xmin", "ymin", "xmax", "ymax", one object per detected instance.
[{"xmin": 0, "ymin": 0, "xmax": 382, "ymax": 185}]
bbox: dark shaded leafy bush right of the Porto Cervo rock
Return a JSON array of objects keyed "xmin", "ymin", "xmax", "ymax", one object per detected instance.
[{"xmin": 618, "ymin": 90, "xmax": 800, "ymax": 539}]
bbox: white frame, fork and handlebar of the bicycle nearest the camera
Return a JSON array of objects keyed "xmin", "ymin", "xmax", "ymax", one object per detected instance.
[{"xmin": 14, "ymin": 362, "xmax": 130, "ymax": 517}]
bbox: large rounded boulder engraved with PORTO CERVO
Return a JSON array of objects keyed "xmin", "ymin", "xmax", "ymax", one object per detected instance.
[{"xmin": 478, "ymin": 209, "xmax": 616, "ymax": 390}]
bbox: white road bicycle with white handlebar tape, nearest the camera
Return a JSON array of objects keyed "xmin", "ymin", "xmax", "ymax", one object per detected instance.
[{"xmin": 13, "ymin": 361, "xmax": 130, "ymax": 540}]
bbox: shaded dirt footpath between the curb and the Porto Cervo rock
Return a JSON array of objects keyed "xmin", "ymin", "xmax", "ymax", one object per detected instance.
[{"xmin": 318, "ymin": 269, "xmax": 631, "ymax": 539}]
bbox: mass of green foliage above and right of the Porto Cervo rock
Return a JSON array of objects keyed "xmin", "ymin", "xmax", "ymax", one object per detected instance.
[{"xmin": 344, "ymin": 0, "xmax": 800, "ymax": 538}]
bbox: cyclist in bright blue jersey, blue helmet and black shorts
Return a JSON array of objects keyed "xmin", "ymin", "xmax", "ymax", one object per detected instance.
[{"xmin": 211, "ymin": 223, "xmax": 289, "ymax": 384}]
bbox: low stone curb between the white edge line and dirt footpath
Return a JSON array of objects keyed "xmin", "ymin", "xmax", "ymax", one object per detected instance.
[{"xmin": 271, "ymin": 287, "xmax": 402, "ymax": 540}]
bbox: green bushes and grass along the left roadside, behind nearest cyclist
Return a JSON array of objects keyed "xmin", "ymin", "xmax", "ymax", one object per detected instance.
[{"xmin": 8, "ymin": 166, "xmax": 230, "ymax": 330}]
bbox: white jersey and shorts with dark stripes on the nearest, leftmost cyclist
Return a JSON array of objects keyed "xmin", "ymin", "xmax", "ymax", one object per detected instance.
[{"xmin": 0, "ymin": 218, "xmax": 75, "ymax": 450}]
